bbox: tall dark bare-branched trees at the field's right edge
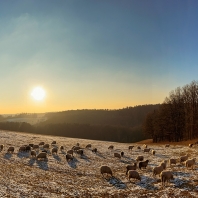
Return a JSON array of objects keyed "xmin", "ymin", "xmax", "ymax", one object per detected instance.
[{"xmin": 143, "ymin": 81, "xmax": 198, "ymax": 142}]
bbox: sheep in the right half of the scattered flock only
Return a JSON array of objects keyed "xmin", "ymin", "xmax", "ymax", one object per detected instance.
[{"xmin": 100, "ymin": 142, "xmax": 198, "ymax": 186}]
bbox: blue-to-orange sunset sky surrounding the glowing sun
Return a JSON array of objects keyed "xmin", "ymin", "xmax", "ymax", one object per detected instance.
[{"xmin": 0, "ymin": 0, "xmax": 198, "ymax": 114}]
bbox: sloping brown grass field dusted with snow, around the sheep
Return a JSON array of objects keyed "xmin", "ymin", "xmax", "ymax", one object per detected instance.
[{"xmin": 0, "ymin": 131, "xmax": 198, "ymax": 198}]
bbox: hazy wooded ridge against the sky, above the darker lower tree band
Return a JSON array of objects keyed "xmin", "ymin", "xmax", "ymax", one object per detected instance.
[{"xmin": 42, "ymin": 104, "xmax": 160, "ymax": 127}]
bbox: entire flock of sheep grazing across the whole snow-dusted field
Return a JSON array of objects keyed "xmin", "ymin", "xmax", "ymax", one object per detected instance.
[{"xmin": 0, "ymin": 141, "xmax": 198, "ymax": 186}]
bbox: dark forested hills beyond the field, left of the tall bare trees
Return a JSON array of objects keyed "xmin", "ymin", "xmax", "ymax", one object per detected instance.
[{"xmin": 0, "ymin": 104, "xmax": 159, "ymax": 142}]
